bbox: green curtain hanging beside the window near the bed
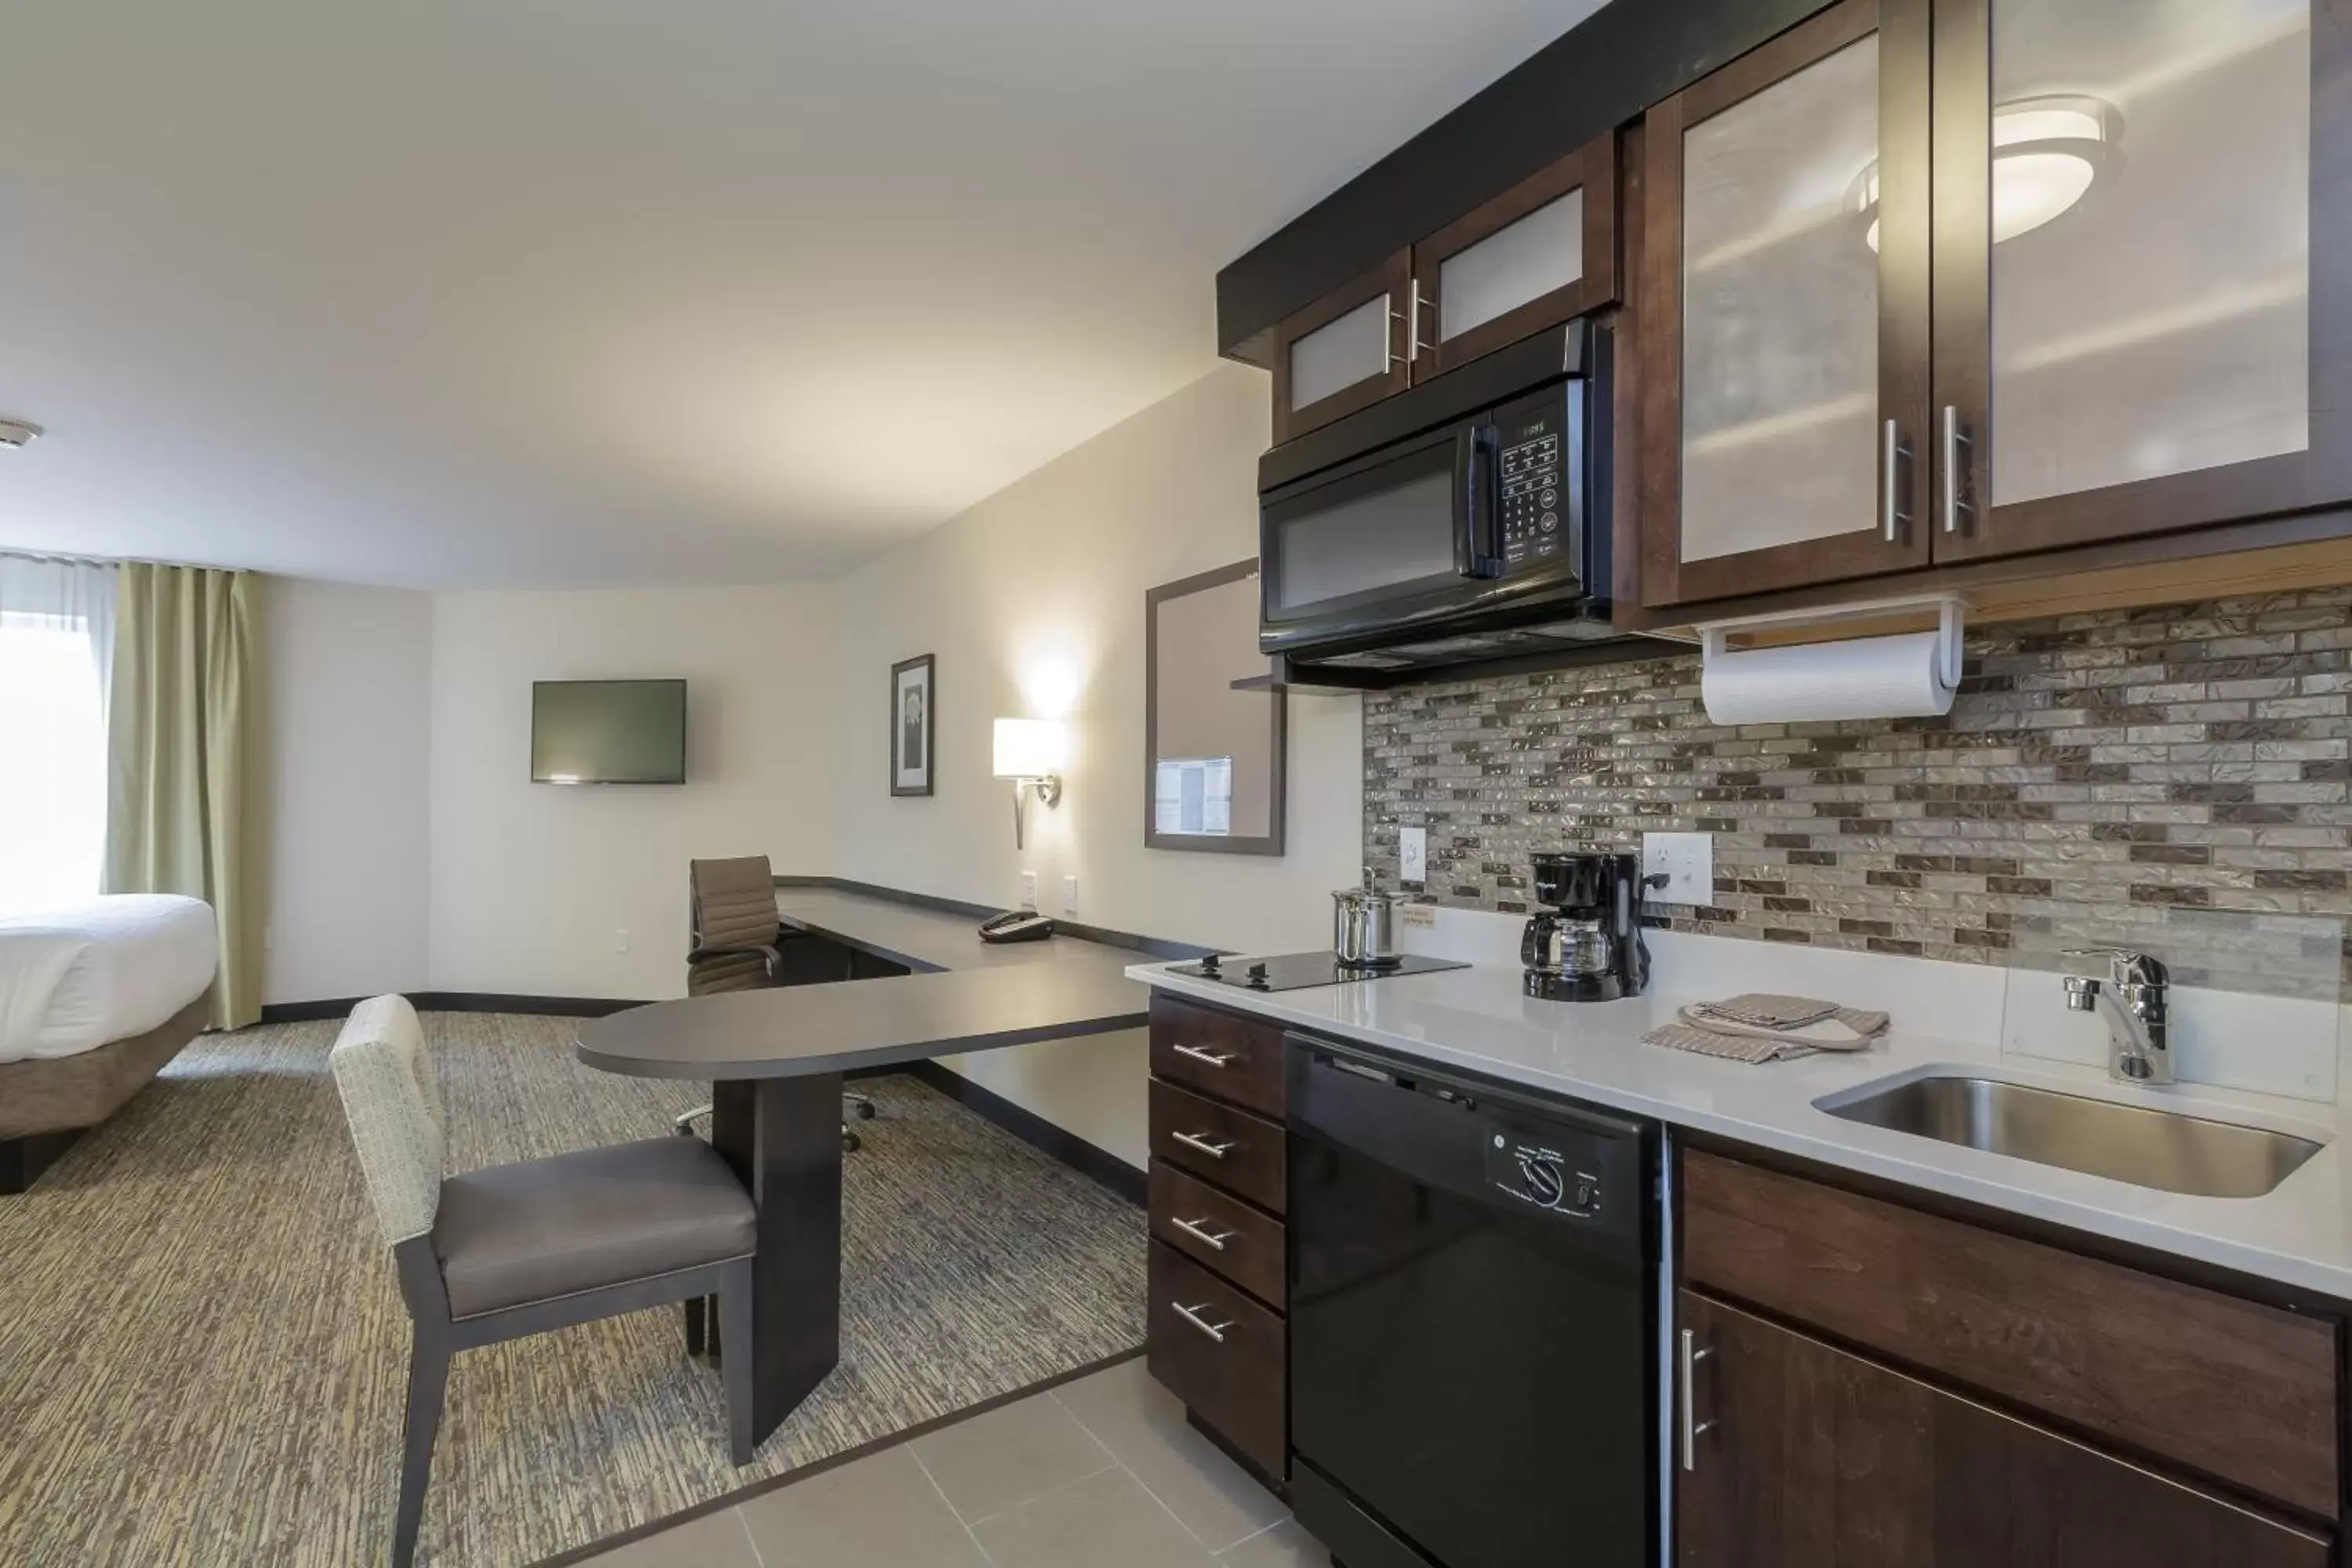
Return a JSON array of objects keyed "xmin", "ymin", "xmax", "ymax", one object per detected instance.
[{"xmin": 106, "ymin": 564, "xmax": 266, "ymax": 1029}]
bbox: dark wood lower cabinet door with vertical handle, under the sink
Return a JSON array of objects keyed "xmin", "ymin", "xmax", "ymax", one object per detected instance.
[{"xmin": 1675, "ymin": 1290, "xmax": 2333, "ymax": 1568}]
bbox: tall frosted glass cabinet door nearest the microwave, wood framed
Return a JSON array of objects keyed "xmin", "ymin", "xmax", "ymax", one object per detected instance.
[{"xmin": 1635, "ymin": 0, "xmax": 1933, "ymax": 604}]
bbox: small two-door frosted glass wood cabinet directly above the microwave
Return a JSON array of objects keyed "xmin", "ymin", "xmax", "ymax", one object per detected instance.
[{"xmin": 1272, "ymin": 132, "xmax": 1618, "ymax": 445}]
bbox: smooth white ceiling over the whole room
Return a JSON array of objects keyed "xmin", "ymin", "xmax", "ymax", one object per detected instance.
[{"xmin": 0, "ymin": 0, "xmax": 1597, "ymax": 588}]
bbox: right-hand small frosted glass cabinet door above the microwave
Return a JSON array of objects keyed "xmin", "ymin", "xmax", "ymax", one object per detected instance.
[{"xmin": 1411, "ymin": 132, "xmax": 1618, "ymax": 381}]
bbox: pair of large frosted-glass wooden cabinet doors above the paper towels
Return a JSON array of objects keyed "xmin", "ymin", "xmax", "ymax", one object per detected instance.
[{"xmin": 1635, "ymin": 0, "xmax": 2352, "ymax": 607}]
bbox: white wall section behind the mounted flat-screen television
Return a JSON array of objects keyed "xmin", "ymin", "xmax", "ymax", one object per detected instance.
[{"xmin": 428, "ymin": 586, "xmax": 842, "ymax": 999}]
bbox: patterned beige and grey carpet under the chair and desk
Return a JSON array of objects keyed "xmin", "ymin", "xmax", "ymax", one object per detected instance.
[{"xmin": 0, "ymin": 1013, "xmax": 1145, "ymax": 1568}]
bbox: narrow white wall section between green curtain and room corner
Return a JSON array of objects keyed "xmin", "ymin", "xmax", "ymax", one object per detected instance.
[{"xmin": 261, "ymin": 579, "xmax": 433, "ymax": 1001}]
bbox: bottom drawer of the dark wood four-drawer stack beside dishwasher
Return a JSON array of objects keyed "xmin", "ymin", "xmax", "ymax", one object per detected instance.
[{"xmin": 1148, "ymin": 1241, "xmax": 1289, "ymax": 1479}]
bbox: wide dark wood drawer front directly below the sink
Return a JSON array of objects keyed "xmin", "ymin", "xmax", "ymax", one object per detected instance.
[{"xmin": 1682, "ymin": 1152, "xmax": 2338, "ymax": 1516}]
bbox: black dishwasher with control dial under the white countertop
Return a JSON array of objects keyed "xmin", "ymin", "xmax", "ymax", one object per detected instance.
[{"xmin": 1284, "ymin": 1034, "xmax": 1658, "ymax": 1568}]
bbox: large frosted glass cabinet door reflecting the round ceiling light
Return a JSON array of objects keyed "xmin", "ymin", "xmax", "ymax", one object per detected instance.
[{"xmin": 1936, "ymin": 0, "xmax": 2345, "ymax": 560}]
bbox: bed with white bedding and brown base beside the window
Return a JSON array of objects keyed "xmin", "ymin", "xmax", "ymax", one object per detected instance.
[{"xmin": 0, "ymin": 893, "xmax": 219, "ymax": 1192}]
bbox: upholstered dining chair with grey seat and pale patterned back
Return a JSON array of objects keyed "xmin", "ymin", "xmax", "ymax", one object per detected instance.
[{"xmin": 327, "ymin": 996, "xmax": 755, "ymax": 1568}]
